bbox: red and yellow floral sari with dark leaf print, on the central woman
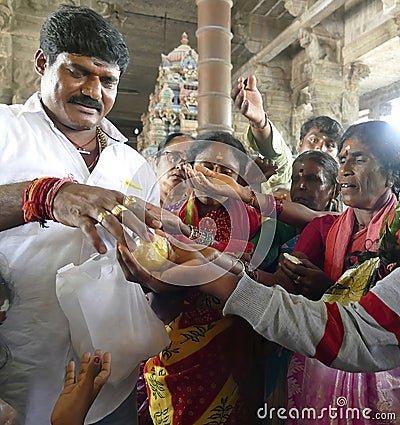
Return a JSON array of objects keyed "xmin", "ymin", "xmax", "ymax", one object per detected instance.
[{"xmin": 144, "ymin": 194, "xmax": 262, "ymax": 425}]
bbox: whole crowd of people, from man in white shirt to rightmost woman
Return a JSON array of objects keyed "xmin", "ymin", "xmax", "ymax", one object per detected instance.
[{"xmin": 0, "ymin": 6, "xmax": 400, "ymax": 425}]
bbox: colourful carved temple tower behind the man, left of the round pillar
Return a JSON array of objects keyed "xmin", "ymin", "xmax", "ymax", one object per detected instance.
[{"xmin": 137, "ymin": 33, "xmax": 198, "ymax": 158}]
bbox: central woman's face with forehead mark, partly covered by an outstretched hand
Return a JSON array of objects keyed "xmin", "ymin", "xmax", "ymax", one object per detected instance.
[{"xmin": 195, "ymin": 142, "xmax": 244, "ymax": 205}]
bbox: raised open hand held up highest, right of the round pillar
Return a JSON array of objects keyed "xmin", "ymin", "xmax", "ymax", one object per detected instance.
[{"xmin": 231, "ymin": 75, "xmax": 265, "ymax": 122}]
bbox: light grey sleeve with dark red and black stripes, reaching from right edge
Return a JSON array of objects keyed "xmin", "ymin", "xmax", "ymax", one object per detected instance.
[{"xmin": 224, "ymin": 269, "xmax": 400, "ymax": 372}]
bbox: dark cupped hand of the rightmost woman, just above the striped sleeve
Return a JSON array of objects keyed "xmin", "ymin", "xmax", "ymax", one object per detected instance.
[{"xmin": 279, "ymin": 252, "xmax": 335, "ymax": 301}]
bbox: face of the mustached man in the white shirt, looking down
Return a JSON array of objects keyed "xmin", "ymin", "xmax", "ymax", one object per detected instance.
[{"xmin": 35, "ymin": 50, "xmax": 120, "ymax": 130}]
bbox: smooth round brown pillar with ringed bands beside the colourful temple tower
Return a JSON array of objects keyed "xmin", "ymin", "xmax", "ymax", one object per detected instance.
[{"xmin": 196, "ymin": 0, "xmax": 232, "ymax": 135}]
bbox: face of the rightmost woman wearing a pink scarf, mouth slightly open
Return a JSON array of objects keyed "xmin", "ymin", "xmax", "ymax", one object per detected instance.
[{"xmin": 339, "ymin": 139, "xmax": 391, "ymax": 210}]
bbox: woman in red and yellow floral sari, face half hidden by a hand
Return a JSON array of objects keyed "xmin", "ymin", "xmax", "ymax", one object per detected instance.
[{"xmin": 144, "ymin": 132, "xmax": 262, "ymax": 425}]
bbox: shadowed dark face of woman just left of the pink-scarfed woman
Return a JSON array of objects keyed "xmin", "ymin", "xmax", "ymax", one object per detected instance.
[{"xmin": 290, "ymin": 159, "xmax": 335, "ymax": 211}]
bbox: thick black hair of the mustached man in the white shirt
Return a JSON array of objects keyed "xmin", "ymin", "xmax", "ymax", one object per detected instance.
[{"xmin": 40, "ymin": 6, "xmax": 129, "ymax": 74}]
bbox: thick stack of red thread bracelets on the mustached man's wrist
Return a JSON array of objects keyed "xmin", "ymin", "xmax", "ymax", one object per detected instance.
[{"xmin": 22, "ymin": 177, "xmax": 77, "ymax": 227}]
